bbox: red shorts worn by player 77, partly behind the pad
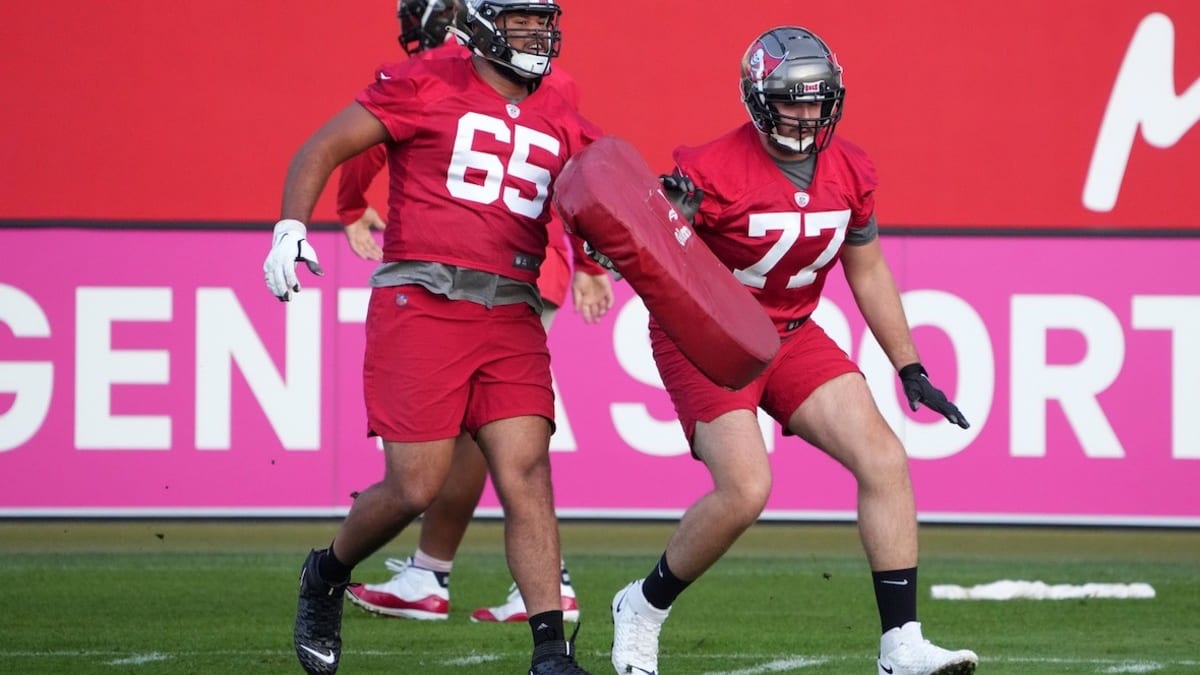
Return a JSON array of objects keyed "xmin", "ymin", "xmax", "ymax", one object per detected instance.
[{"xmin": 650, "ymin": 319, "xmax": 860, "ymax": 443}]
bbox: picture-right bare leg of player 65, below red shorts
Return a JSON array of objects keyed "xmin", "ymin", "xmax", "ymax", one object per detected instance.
[{"xmin": 478, "ymin": 416, "xmax": 562, "ymax": 616}]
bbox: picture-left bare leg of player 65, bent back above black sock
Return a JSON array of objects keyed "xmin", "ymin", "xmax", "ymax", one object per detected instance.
[{"xmin": 332, "ymin": 438, "xmax": 454, "ymax": 567}]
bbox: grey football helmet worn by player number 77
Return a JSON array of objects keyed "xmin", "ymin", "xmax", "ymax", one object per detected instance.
[{"xmin": 742, "ymin": 26, "xmax": 846, "ymax": 154}]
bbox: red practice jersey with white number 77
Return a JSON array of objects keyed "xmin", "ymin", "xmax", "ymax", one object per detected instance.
[{"xmin": 674, "ymin": 123, "xmax": 877, "ymax": 333}]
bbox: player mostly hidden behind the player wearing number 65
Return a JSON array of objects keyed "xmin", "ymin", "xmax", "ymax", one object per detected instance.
[{"xmin": 337, "ymin": 0, "xmax": 613, "ymax": 622}]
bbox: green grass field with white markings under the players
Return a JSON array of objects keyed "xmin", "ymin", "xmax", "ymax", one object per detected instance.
[{"xmin": 0, "ymin": 520, "xmax": 1200, "ymax": 675}]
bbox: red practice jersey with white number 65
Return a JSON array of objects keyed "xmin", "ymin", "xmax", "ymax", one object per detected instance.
[{"xmin": 358, "ymin": 48, "xmax": 601, "ymax": 282}]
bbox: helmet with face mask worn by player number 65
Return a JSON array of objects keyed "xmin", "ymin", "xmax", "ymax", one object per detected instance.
[{"xmin": 456, "ymin": 0, "xmax": 563, "ymax": 82}]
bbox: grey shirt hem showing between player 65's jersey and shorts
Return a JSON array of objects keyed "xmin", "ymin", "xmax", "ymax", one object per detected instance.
[{"xmin": 371, "ymin": 261, "xmax": 542, "ymax": 313}]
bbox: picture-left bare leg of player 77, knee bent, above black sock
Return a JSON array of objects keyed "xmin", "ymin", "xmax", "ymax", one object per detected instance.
[{"xmin": 666, "ymin": 411, "xmax": 770, "ymax": 581}]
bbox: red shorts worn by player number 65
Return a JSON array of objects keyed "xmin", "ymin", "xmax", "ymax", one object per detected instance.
[{"xmin": 362, "ymin": 286, "xmax": 554, "ymax": 442}]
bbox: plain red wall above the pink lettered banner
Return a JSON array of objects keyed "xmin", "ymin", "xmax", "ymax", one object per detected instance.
[{"xmin": 0, "ymin": 0, "xmax": 1200, "ymax": 229}]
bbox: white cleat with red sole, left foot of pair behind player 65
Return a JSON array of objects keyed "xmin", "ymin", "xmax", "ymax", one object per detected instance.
[{"xmin": 346, "ymin": 557, "xmax": 450, "ymax": 620}]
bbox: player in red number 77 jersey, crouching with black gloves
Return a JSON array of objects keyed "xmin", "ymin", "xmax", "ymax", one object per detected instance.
[{"xmin": 612, "ymin": 26, "xmax": 978, "ymax": 675}]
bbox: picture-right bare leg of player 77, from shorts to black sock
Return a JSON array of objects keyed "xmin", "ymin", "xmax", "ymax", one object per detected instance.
[{"xmin": 787, "ymin": 374, "xmax": 917, "ymax": 571}]
